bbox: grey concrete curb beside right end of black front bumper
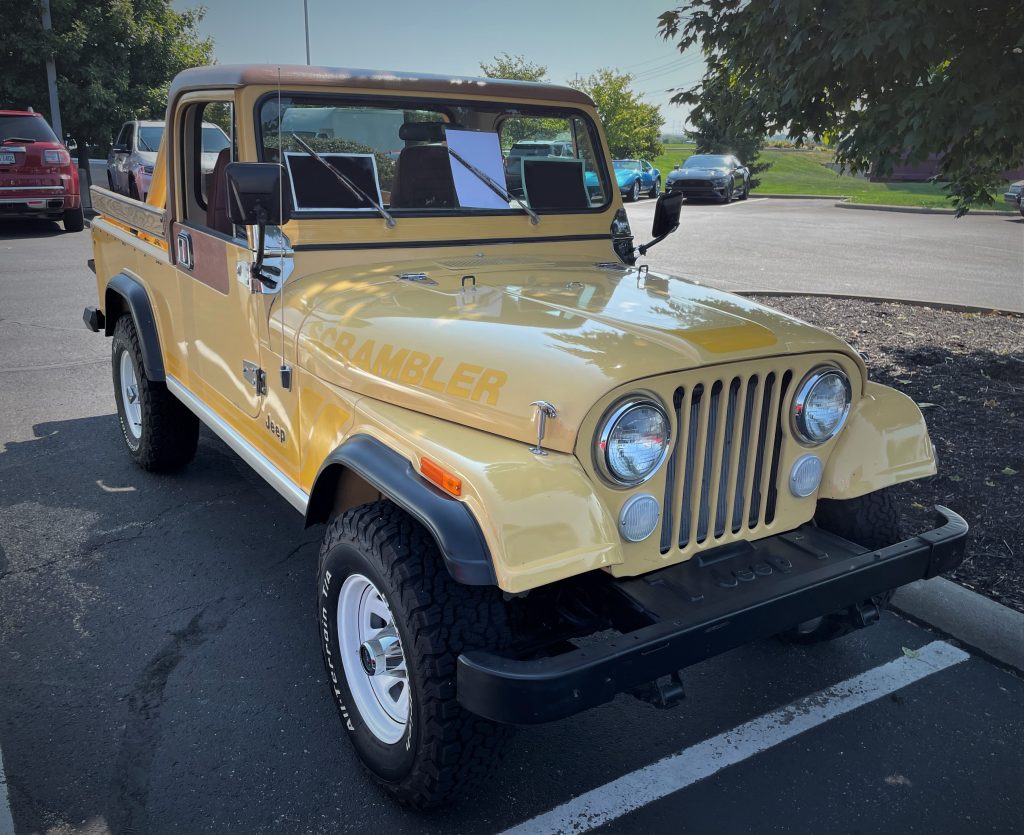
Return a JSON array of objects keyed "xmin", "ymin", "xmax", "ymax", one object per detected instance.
[{"xmin": 891, "ymin": 577, "xmax": 1024, "ymax": 672}]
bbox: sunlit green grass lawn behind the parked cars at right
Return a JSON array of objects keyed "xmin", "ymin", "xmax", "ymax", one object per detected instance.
[{"xmin": 654, "ymin": 144, "xmax": 1013, "ymax": 212}]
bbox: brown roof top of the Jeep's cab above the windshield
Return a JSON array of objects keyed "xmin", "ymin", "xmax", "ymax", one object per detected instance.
[{"xmin": 169, "ymin": 64, "xmax": 594, "ymax": 107}]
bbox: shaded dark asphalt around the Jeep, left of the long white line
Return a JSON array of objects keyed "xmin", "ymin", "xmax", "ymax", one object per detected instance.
[{"xmin": 0, "ymin": 415, "xmax": 966, "ymax": 833}]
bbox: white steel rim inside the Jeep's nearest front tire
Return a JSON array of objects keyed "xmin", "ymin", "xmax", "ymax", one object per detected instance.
[{"xmin": 337, "ymin": 574, "xmax": 410, "ymax": 745}]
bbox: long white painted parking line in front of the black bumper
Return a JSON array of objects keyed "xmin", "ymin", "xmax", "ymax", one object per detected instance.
[{"xmin": 502, "ymin": 640, "xmax": 970, "ymax": 835}]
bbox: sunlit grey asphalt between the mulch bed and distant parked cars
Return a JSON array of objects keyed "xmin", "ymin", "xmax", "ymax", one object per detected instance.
[{"xmin": 627, "ymin": 192, "xmax": 1024, "ymax": 311}]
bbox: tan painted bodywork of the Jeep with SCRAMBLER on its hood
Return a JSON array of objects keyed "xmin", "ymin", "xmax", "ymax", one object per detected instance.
[{"xmin": 92, "ymin": 67, "xmax": 935, "ymax": 592}]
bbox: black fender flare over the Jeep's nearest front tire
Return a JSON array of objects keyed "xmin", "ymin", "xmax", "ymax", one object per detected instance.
[{"xmin": 306, "ymin": 434, "xmax": 498, "ymax": 586}]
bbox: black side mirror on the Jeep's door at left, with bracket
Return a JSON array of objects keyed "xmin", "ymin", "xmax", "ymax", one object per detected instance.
[{"xmin": 222, "ymin": 162, "xmax": 292, "ymax": 290}]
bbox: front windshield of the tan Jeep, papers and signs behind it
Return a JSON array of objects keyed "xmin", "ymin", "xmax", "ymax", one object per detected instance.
[{"xmin": 259, "ymin": 94, "xmax": 611, "ymax": 217}]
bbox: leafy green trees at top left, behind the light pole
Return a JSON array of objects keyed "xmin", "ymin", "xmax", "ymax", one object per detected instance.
[{"xmin": 0, "ymin": 0, "xmax": 213, "ymax": 153}]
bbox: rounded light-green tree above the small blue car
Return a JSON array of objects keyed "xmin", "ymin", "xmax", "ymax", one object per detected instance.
[{"xmin": 569, "ymin": 70, "xmax": 665, "ymax": 160}]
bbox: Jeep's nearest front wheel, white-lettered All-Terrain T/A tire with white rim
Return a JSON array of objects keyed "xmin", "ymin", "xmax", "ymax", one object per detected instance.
[{"xmin": 316, "ymin": 501, "xmax": 509, "ymax": 808}]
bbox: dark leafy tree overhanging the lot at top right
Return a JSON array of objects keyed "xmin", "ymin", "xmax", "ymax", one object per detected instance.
[{"xmin": 658, "ymin": 0, "xmax": 1024, "ymax": 214}]
